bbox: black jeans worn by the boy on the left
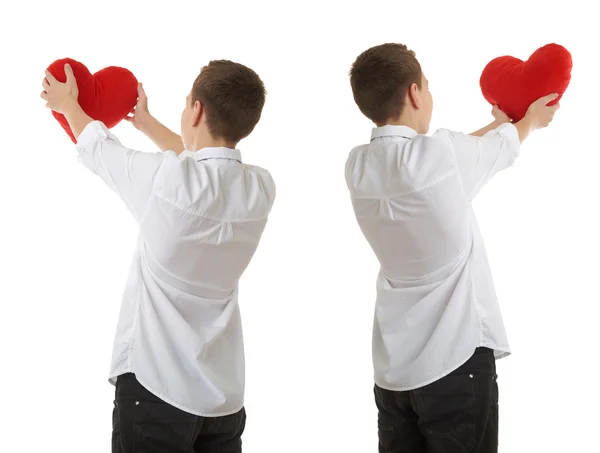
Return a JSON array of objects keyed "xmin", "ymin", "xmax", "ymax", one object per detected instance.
[{"xmin": 112, "ymin": 373, "xmax": 246, "ymax": 453}]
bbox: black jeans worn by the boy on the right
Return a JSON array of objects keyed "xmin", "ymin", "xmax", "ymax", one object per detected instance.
[{"xmin": 375, "ymin": 348, "xmax": 498, "ymax": 453}]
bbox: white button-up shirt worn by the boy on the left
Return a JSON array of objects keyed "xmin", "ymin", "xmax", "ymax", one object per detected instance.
[{"xmin": 77, "ymin": 121, "xmax": 275, "ymax": 417}]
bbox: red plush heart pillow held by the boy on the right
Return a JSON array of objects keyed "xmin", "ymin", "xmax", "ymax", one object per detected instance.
[{"xmin": 479, "ymin": 44, "xmax": 573, "ymax": 121}]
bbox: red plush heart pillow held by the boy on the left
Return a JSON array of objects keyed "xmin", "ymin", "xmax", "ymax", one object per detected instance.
[{"xmin": 48, "ymin": 58, "xmax": 138, "ymax": 143}]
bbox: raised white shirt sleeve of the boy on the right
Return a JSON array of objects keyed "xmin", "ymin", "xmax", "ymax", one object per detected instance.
[{"xmin": 434, "ymin": 123, "xmax": 521, "ymax": 200}]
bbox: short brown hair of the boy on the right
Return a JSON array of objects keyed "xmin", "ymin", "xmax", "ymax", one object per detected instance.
[{"xmin": 350, "ymin": 44, "xmax": 423, "ymax": 124}]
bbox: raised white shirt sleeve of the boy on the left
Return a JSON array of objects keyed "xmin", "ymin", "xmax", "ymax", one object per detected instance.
[{"xmin": 76, "ymin": 121, "xmax": 165, "ymax": 222}]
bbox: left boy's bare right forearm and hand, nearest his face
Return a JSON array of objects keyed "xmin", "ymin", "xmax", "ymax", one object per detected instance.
[{"xmin": 126, "ymin": 83, "xmax": 184, "ymax": 154}]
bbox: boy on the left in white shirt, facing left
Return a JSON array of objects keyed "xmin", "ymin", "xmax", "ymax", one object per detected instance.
[{"xmin": 41, "ymin": 60, "xmax": 275, "ymax": 453}]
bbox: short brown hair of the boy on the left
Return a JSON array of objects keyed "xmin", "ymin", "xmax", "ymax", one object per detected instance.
[{"xmin": 190, "ymin": 60, "xmax": 267, "ymax": 143}]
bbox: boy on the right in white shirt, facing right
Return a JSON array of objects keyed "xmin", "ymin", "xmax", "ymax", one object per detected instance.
[{"xmin": 346, "ymin": 44, "xmax": 558, "ymax": 453}]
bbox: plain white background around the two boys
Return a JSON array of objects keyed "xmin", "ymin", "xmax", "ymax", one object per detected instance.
[{"xmin": 0, "ymin": 0, "xmax": 600, "ymax": 453}]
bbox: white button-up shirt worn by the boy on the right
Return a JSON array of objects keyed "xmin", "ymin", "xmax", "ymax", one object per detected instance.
[{"xmin": 346, "ymin": 124, "xmax": 520, "ymax": 391}]
